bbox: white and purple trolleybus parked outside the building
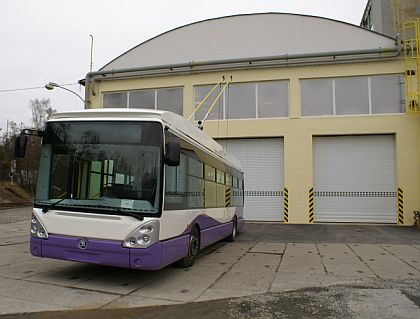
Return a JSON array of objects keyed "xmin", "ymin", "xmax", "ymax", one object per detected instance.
[{"xmin": 15, "ymin": 109, "xmax": 244, "ymax": 270}]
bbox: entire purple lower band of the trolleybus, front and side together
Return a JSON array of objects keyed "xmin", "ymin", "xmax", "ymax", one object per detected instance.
[{"xmin": 30, "ymin": 208, "xmax": 244, "ymax": 270}]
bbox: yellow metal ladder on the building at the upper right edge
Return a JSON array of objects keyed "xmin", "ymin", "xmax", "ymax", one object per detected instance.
[{"xmin": 403, "ymin": 19, "xmax": 420, "ymax": 113}]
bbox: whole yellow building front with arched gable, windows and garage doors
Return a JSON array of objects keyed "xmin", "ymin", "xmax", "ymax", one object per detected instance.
[{"xmin": 85, "ymin": 13, "xmax": 420, "ymax": 225}]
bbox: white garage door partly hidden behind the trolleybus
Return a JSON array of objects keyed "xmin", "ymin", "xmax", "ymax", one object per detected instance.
[{"xmin": 219, "ymin": 138, "xmax": 284, "ymax": 221}]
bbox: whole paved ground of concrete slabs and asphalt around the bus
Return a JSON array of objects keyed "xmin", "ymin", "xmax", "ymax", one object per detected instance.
[{"xmin": 0, "ymin": 208, "xmax": 420, "ymax": 319}]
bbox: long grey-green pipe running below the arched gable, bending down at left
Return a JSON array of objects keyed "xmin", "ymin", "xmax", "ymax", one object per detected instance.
[{"xmin": 85, "ymin": 45, "xmax": 401, "ymax": 108}]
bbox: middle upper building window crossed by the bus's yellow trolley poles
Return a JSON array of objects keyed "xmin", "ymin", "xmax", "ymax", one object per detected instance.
[{"xmin": 194, "ymin": 81, "xmax": 289, "ymax": 120}]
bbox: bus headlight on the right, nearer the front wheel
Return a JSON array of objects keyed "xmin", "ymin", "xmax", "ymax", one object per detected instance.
[{"xmin": 123, "ymin": 220, "xmax": 159, "ymax": 248}]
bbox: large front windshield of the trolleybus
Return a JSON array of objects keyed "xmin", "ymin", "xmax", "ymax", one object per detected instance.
[{"xmin": 35, "ymin": 121, "xmax": 163, "ymax": 215}]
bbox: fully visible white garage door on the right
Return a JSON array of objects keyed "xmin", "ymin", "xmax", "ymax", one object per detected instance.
[{"xmin": 313, "ymin": 135, "xmax": 397, "ymax": 223}]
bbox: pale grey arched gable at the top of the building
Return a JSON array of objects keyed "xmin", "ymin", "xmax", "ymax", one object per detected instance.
[{"xmin": 101, "ymin": 13, "xmax": 395, "ymax": 71}]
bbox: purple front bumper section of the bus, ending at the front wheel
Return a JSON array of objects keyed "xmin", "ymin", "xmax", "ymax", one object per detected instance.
[{"xmin": 30, "ymin": 235, "xmax": 188, "ymax": 270}]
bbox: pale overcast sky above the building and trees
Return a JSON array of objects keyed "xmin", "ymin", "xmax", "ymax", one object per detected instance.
[{"xmin": 0, "ymin": 0, "xmax": 367, "ymax": 133}]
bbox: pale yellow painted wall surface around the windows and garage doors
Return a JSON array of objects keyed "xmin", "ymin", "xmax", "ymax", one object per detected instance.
[{"xmin": 89, "ymin": 60, "xmax": 420, "ymax": 225}]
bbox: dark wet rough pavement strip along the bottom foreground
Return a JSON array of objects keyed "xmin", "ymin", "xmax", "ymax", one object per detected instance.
[{"xmin": 0, "ymin": 280, "xmax": 420, "ymax": 319}]
